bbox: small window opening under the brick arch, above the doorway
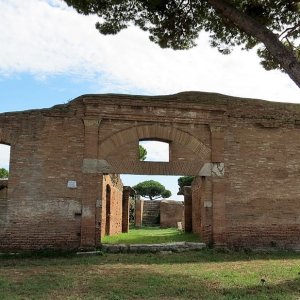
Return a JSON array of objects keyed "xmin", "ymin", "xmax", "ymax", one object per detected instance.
[{"xmin": 139, "ymin": 140, "xmax": 170, "ymax": 162}]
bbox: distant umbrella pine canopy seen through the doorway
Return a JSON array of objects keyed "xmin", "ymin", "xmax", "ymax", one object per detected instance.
[{"xmin": 133, "ymin": 180, "xmax": 172, "ymax": 200}]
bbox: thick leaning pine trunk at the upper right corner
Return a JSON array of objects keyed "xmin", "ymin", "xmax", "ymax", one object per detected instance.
[{"xmin": 206, "ymin": 0, "xmax": 300, "ymax": 87}]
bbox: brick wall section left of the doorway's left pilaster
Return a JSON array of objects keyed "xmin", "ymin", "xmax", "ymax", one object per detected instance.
[{"xmin": 0, "ymin": 106, "xmax": 83, "ymax": 249}]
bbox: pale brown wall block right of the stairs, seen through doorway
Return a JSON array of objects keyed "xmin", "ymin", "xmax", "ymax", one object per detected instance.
[{"xmin": 160, "ymin": 200, "xmax": 184, "ymax": 228}]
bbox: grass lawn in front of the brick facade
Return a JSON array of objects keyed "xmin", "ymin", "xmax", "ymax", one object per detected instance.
[{"xmin": 0, "ymin": 249, "xmax": 300, "ymax": 300}]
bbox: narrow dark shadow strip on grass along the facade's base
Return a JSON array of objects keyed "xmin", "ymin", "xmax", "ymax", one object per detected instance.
[{"xmin": 0, "ymin": 249, "xmax": 300, "ymax": 268}]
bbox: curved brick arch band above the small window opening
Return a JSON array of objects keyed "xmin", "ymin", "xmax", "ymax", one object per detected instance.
[{"xmin": 99, "ymin": 125, "xmax": 211, "ymax": 160}]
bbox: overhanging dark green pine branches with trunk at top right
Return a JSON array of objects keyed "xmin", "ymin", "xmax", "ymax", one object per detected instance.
[{"xmin": 64, "ymin": 0, "xmax": 300, "ymax": 87}]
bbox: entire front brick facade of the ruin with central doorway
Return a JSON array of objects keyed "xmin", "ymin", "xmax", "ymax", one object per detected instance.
[{"xmin": 0, "ymin": 93, "xmax": 300, "ymax": 250}]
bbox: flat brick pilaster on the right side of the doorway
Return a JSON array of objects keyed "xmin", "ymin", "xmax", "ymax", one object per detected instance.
[{"xmin": 210, "ymin": 126, "xmax": 226, "ymax": 246}]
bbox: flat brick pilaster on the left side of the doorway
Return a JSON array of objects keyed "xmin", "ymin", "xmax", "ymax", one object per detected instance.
[{"xmin": 80, "ymin": 118, "xmax": 102, "ymax": 248}]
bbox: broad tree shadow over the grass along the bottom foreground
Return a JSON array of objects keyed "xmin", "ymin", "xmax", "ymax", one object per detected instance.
[{"xmin": 0, "ymin": 265, "xmax": 300, "ymax": 300}]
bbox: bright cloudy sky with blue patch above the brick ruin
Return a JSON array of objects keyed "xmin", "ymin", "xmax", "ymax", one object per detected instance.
[{"xmin": 0, "ymin": 0, "xmax": 300, "ymax": 199}]
